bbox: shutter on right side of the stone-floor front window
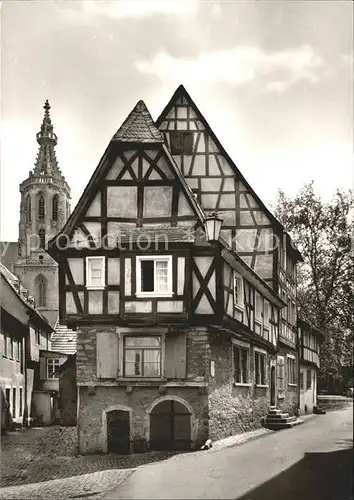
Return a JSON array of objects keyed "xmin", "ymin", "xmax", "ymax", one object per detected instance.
[{"xmin": 165, "ymin": 332, "xmax": 187, "ymax": 379}]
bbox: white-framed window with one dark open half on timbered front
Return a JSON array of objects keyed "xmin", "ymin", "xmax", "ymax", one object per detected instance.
[{"xmin": 136, "ymin": 255, "xmax": 172, "ymax": 297}]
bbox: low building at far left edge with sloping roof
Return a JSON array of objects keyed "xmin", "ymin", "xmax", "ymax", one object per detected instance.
[{"xmin": 0, "ymin": 264, "xmax": 53, "ymax": 430}]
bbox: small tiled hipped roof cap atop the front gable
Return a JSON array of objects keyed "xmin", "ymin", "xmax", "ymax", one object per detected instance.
[{"xmin": 112, "ymin": 101, "xmax": 164, "ymax": 143}]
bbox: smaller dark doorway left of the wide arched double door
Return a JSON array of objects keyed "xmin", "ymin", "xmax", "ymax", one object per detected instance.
[{"xmin": 107, "ymin": 410, "xmax": 130, "ymax": 454}]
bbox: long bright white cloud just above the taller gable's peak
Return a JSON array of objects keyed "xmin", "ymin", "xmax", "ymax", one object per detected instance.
[{"xmin": 135, "ymin": 45, "xmax": 323, "ymax": 92}]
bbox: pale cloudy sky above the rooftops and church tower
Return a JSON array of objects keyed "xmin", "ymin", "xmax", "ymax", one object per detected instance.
[{"xmin": 0, "ymin": 0, "xmax": 353, "ymax": 241}]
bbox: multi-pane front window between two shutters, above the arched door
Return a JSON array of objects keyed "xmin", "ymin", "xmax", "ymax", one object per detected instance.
[{"xmin": 124, "ymin": 336, "xmax": 162, "ymax": 378}]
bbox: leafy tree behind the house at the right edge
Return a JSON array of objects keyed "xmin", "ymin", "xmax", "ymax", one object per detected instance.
[{"xmin": 275, "ymin": 182, "xmax": 354, "ymax": 388}]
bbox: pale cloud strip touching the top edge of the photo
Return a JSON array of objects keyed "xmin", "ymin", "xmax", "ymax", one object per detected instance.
[{"xmin": 61, "ymin": 0, "xmax": 198, "ymax": 24}]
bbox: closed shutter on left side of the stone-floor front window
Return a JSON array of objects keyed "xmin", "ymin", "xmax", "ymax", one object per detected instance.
[{"xmin": 96, "ymin": 332, "xmax": 119, "ymax": 378}]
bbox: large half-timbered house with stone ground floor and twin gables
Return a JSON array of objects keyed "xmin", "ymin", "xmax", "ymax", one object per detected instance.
[{"xmin": 48, "ymin": 87, "xmax": 310, "ymax": 453}]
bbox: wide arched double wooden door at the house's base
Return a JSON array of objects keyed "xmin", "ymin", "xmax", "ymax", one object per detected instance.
[{"xmin": 150, "ymin": 399, "xmax": 191, "ymax": 450}]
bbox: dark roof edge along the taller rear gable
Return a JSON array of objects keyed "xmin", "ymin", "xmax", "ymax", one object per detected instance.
[{"xmin": 155, "ymin": 85, "xmax": 303, "ymax": 261}]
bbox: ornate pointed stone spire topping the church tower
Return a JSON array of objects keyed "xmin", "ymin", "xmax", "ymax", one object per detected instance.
[{"xmin": 33, "ymin": 99, "xmax": 61, "ymax": 177}]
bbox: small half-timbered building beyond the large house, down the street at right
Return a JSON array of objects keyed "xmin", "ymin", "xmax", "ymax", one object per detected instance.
[{"xmin": 298, "ymin": 319, "xmax": 325, "ymax": 414}]
